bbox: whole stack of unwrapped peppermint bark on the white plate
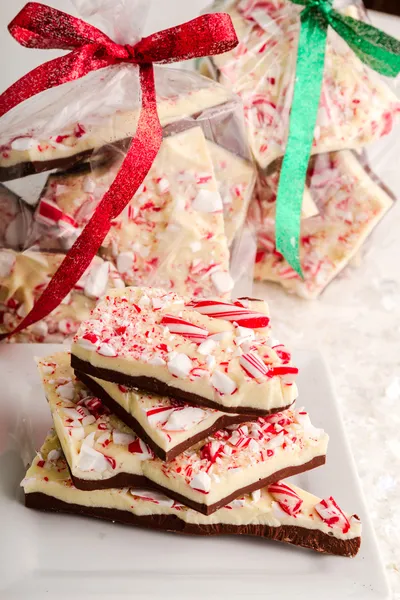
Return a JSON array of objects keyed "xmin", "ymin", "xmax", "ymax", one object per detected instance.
[{"xmin": 22, "ymin": 287, "xmax": 361, "ymax": 556}]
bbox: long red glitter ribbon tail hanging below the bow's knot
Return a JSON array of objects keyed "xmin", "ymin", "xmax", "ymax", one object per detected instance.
[{"xmin": 0, "ymin": 65, "xmax": 162, "ymax": 340}]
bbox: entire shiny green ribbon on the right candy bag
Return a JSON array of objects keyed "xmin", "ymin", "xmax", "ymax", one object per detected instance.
[{"xmin": 275, "ymin": 0, "xmax": 400, "ymax": 276}]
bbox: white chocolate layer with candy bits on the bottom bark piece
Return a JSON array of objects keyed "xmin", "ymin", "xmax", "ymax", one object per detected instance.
[{"xmin": 21, "ymin": 433, "xmax": 361, "ymax": 540}]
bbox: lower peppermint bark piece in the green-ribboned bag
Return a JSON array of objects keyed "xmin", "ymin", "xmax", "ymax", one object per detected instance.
[{"xmin": 249, "ymin": 150, "xmax": 393, "ymax": 299}]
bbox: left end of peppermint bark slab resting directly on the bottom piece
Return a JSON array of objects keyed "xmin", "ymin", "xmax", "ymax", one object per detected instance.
[{"xmin": 38, "ymin": 352, "xmax": 153, "ymax": 490}]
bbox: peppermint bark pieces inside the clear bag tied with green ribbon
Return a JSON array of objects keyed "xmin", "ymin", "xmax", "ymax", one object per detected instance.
[{"xmin": 200, "ymin": 0, "xmax": 400, "ymax": 298}]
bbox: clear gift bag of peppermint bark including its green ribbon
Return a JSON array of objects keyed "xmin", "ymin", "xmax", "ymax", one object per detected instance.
[{"xmin": 199, "ymin": 0, "xmax": 400, "ymax": 298}]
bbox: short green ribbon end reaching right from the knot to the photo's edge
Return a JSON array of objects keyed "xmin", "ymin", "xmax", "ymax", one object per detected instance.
[{"xmin": 328, "ymin": 10, "xmax": 400, "ymax": 77}]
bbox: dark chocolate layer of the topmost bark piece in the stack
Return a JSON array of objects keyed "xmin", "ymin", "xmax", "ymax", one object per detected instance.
[{"xmin": 71, "ymin": 354, "xmax": 291, "ymax": 418}]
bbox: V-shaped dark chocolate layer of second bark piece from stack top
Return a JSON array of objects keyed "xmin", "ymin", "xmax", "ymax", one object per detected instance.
[{"xmin": 75, "ymin": 371, "xmax": 256, "ymax": 462}]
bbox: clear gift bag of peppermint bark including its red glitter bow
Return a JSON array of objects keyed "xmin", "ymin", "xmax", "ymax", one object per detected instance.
[{"xmin": 0, "ymin": 0, "xmax": 256, "ymax": 342}]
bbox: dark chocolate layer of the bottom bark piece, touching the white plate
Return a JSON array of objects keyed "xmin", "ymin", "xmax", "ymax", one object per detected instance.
[{"xmin": 25, "ymin": 492, "xmax": 361, "ymax": 557}]
